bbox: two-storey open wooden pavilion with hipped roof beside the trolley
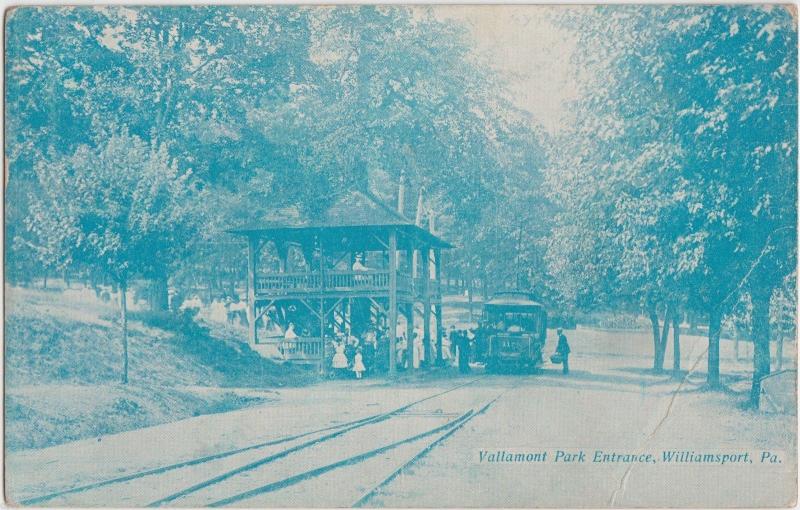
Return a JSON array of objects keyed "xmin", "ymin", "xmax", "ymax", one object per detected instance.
[{"xmin": 231, "ymin": 190, "xmax": 451, "ymax": 375}]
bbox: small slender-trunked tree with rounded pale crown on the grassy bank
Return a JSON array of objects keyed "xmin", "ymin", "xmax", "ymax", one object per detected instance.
[{"xmin": 26, "ymin": 129, "xmax": 200, "ymax": 383}]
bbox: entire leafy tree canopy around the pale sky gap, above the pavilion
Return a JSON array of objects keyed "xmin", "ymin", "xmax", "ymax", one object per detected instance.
[{"xmin": 5, "ymin": 5, "xmax": 797, "ymax": 402}]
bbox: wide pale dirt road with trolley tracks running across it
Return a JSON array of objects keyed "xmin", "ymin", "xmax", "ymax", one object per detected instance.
[{"xmin": 7, "ymin": 330, "xmax": 796, "ymax": 507}]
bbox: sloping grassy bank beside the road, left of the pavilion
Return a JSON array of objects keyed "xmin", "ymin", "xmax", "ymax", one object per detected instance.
[{"xmin": 5, "ymin": 287, "xmax": 315, "ymax": 451}]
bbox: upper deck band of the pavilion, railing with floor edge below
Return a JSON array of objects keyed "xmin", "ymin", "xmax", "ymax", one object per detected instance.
[{"xmin": 255, "ymin": 270, "xmax": 441, "ymax": 302}]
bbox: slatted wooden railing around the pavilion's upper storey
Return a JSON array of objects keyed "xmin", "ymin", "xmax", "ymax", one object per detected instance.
[{"xmin": 255, "ymin": 270, "xmax": 432, "ymax": 295}]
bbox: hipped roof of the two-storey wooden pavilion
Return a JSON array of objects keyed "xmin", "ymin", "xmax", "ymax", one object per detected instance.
[{"xmin": 229, "ymin": 189, "xmax": 451, "ymax": 249}]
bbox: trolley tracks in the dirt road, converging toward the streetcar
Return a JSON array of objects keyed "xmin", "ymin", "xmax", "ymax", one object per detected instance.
[{"xmin": 21, "ymin": 379, "xmax": 511, "ymax": 507}]
